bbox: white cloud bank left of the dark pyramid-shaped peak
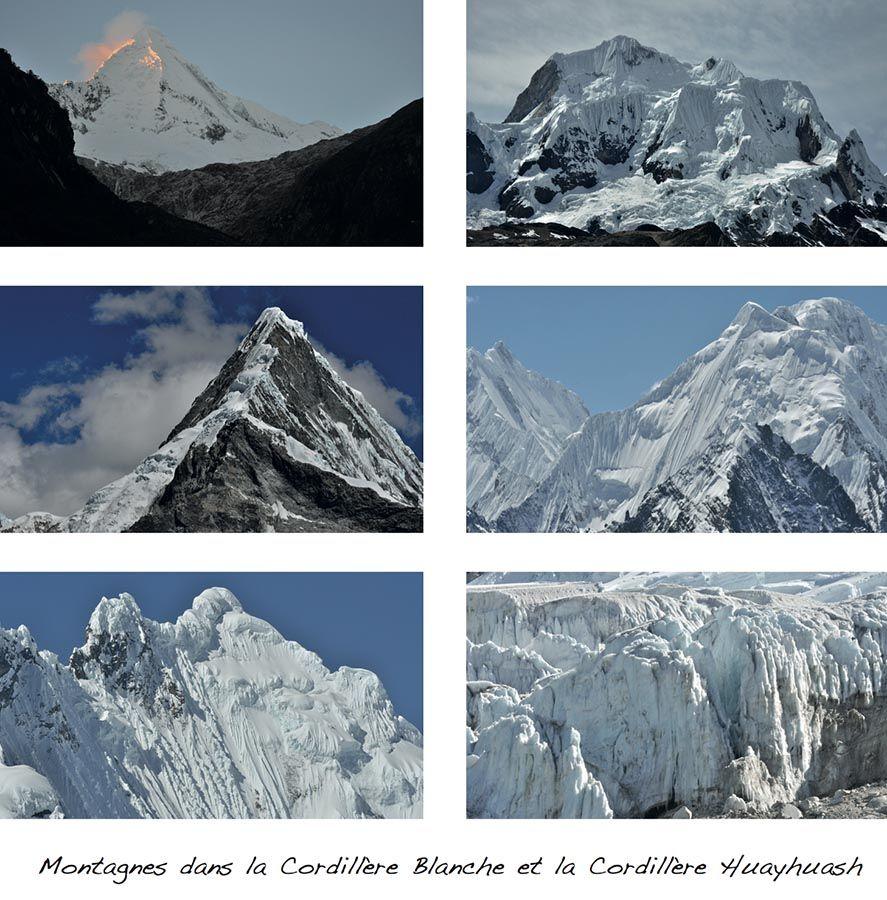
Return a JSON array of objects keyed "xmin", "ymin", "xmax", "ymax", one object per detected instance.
[{"xmin": 0, "ymin": 288, "xmax": 249, "ymax": 516}]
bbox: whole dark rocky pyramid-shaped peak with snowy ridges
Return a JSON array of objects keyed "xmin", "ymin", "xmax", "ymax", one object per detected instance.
[{"xmin": 2, "ymin": 307, "xmax": 422, "ymax": 532}]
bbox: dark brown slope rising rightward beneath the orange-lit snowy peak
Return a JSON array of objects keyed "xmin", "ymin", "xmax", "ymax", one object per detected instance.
[{"xmin": 83, "ymin": 100, "xmax": 422, "ymax": 246}]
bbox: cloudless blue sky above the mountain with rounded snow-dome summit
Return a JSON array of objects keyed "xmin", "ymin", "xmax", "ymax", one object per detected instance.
[{"xmin": 0, "ymin": 572, "xmax": 422, "ymax": 728}]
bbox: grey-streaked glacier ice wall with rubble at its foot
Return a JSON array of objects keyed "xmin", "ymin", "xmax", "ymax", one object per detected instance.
[{"xmin": 467, "ymin": 575, "xmax": 887, "ymax": 818}]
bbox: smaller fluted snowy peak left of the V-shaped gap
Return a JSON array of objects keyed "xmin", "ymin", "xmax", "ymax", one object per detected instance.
[{"xmin": 468, "ymin": 341, "xmax": 588, "ymax": 521}]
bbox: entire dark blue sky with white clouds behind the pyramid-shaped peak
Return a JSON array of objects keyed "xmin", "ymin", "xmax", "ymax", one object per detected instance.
[{"xmin": 0, "ymin": 287, "xmax": 422, "ymax": 516}]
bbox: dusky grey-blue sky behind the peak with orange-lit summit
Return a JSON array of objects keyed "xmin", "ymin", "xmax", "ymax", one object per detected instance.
[{"xmin": 0, "ymin": 0, "xmax": 422, "ymax": 131}]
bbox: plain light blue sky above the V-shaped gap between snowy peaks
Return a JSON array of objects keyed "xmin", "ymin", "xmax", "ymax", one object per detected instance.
[{"xmin": 468, "ymin": 287, "xmax": 887, "ymax": 412}]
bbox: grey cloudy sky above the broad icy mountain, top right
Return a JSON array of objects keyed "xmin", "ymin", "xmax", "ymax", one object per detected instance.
[{"xmin": 468, "ymin": 0, "xmax": 887, "ymax": 170}]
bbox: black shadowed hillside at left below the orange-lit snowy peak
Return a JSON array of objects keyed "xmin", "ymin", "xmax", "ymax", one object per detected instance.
[{"xmin": 0, "ymin": 50, "xmax": 232, "ymax": 246}]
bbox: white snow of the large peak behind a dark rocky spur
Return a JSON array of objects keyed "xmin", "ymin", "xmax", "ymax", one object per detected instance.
[{"xmin": 469, "ymin": 297, "xmax": 887, "ymax": 531}]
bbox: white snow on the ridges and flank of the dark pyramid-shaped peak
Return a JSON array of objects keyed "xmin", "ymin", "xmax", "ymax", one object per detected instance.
[{"xmin": 0, "ymin": 307, "xmax": 422, "ymax": 532}]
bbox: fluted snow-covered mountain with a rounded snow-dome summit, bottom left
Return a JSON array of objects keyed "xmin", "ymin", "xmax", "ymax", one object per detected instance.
[{"xmin": 0, "ymin": 588, "xmax": 422, "ymax": 818}]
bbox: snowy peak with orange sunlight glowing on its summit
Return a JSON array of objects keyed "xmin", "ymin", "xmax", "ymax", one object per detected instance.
[{"xmin": 49, "ymin": 28, "xmax": 342, "ymax": 173}]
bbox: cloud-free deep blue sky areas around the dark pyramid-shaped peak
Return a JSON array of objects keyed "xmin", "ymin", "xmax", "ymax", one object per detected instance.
[{"xmin": 0, "ymin": 287, "xmax": 422, "ymax": 458}]
